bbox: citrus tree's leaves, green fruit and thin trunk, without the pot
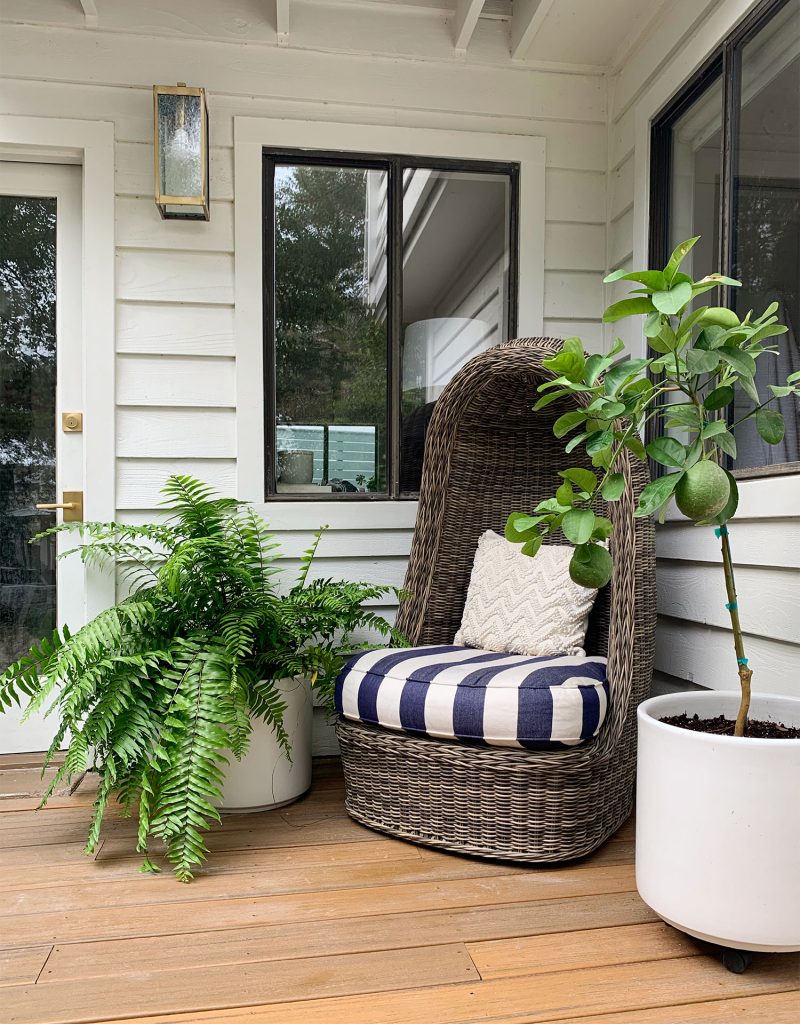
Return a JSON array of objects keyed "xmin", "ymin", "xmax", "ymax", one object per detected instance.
[{"xmin": 506, "ymin": 238, "xmax": 800, "ymax": 735}]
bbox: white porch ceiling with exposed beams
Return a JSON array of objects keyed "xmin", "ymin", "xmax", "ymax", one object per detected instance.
[{"xmin": 2, "ymin": 0, "xmax": 668, "ymax": 73}]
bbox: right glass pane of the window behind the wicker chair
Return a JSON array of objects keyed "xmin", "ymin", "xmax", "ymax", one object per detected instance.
[{"xmin": 399, "ymin": 169, "xmax": 511, "ymax": 494}]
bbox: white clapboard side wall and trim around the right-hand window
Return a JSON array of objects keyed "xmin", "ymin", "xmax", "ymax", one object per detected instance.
[{"xmin": 606, "ymin": 0, "xmax": 800, "ymax": 694}]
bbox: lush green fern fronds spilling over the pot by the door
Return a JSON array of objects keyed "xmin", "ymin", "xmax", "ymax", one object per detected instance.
[{"xmin": 0, "ymin": 476, "xmax": 399, "ymax": 882}]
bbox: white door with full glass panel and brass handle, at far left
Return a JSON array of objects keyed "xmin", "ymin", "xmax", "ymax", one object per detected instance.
[{"xmin": 0, "ymin": 163, "xmax": 84, "ymax": 754}]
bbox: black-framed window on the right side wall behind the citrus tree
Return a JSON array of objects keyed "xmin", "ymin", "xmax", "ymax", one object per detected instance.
[{"xmin": 650, "ymin": 0, "xmax": 800, "ymax": 476}]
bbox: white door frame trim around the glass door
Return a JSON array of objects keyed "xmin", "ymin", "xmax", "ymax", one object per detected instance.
[{"xmin": 0, "ymin": 115, "xmax": 116, "ymax": 620}]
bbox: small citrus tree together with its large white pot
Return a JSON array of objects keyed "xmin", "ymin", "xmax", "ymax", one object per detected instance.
[{"xmin": 506, "ymin": 239, "xmax": 800, "ymax": 950}]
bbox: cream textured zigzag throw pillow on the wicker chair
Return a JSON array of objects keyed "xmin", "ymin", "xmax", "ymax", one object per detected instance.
[{"xmin": 454, "ymin": 529, "xmax": 597, "ymax": 655}]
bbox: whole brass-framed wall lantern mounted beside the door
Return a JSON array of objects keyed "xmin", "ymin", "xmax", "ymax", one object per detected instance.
[{"xmin": 153, "ymin": 84, "xmax": 209, "ymax": 220}]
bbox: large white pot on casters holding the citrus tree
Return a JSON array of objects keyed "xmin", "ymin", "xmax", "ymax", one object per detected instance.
[{"xmin": 636, "ymin": 691, "xmax": 800, "ymax": 952}]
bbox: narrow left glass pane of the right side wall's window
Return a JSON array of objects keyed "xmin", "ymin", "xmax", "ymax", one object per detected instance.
[{"xmin": 668, "ymin": 79, "xmax": 722, "ymax": 288}]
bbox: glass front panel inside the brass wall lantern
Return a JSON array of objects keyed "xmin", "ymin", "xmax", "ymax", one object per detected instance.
[{"xmin": 158, "ymin": 93, "xmax": 203, "ymax": 197}]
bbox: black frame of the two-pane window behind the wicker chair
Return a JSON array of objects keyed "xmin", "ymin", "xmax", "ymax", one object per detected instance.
[{"xmin": 261, "ymin": 146, "xmax": 520, "ymax": 502}]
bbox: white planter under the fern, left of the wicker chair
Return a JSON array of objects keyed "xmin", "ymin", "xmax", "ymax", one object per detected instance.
[{"xmin": 220, "ymin": 678, "xmax": 313, "ymax": 813}]
